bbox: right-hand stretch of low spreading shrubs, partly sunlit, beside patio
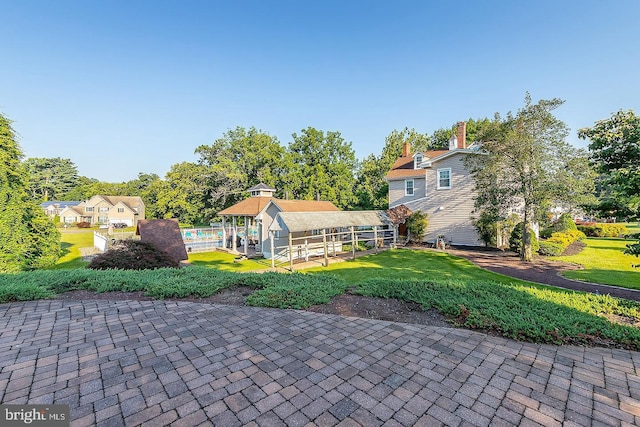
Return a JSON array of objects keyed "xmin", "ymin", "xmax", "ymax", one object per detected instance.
[{"xmin": 353, "ymin": 278, "xmax": 640, "ymax": 349}]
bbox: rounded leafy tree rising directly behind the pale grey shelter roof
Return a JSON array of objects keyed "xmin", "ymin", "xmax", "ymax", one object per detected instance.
[{"xmin": 283, "ymin": 127, "xmax": 357, "ymax": 209}]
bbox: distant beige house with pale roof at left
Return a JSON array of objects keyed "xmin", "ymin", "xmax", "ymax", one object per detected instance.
[{"xmin": 59, "ymin": 195, "xmax": 145, "ymax": 226}]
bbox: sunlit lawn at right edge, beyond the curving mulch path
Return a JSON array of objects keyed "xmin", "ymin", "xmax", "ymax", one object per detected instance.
[{"xmin": 550, "ymin": 237, "xmax": 640, "ymax": 289}]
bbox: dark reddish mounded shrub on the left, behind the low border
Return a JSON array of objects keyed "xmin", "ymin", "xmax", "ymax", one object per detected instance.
[{"xmin": 88, "ymin": 240, "xmax": 180, "ymax": 270}]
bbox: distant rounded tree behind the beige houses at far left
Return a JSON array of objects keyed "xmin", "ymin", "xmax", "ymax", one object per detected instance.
[{"xmin": 24, "ymin": 157, "xmax": 78, "ymax": 202}]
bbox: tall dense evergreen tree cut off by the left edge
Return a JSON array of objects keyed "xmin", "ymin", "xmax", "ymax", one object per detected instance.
[{"xmin": 0, "ymin": 114, "xmax": 60, "ymax": 273}]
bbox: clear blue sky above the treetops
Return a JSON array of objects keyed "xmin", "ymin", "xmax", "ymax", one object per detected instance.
[{"xmin": 0, "ymin": 0, "xmax": 640, "ymax": 182}]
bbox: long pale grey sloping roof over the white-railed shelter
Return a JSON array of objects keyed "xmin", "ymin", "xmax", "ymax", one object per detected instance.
[{"xmin": 269, "ymin": 211, "xmax": 393, "ymax": 233}]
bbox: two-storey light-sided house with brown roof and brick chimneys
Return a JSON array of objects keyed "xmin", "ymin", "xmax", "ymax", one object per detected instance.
[{"xmin": 385, "ymin": 122, "xmax": 482, "ymax": 246}]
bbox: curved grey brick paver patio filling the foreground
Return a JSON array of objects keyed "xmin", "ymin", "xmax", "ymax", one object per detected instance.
[{"xmin": 0, "ymin": 300, "xmax": 640, "ymax": 427}]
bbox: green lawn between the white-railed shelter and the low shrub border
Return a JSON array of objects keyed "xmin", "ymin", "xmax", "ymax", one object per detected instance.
[{"xmin": 304, "ymin": 249, "xmax": 528, "ymax": 284}]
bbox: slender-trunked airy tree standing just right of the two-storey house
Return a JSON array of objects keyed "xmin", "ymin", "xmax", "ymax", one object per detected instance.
[{"xmin": 469, "ymin": 93, "xmax": 579, "ymax": 261}]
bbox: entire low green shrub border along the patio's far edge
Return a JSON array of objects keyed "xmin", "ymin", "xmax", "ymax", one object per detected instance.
[{"xmin": 0, "ymin": 262, "xmax": 640, "ymax": 351}]
